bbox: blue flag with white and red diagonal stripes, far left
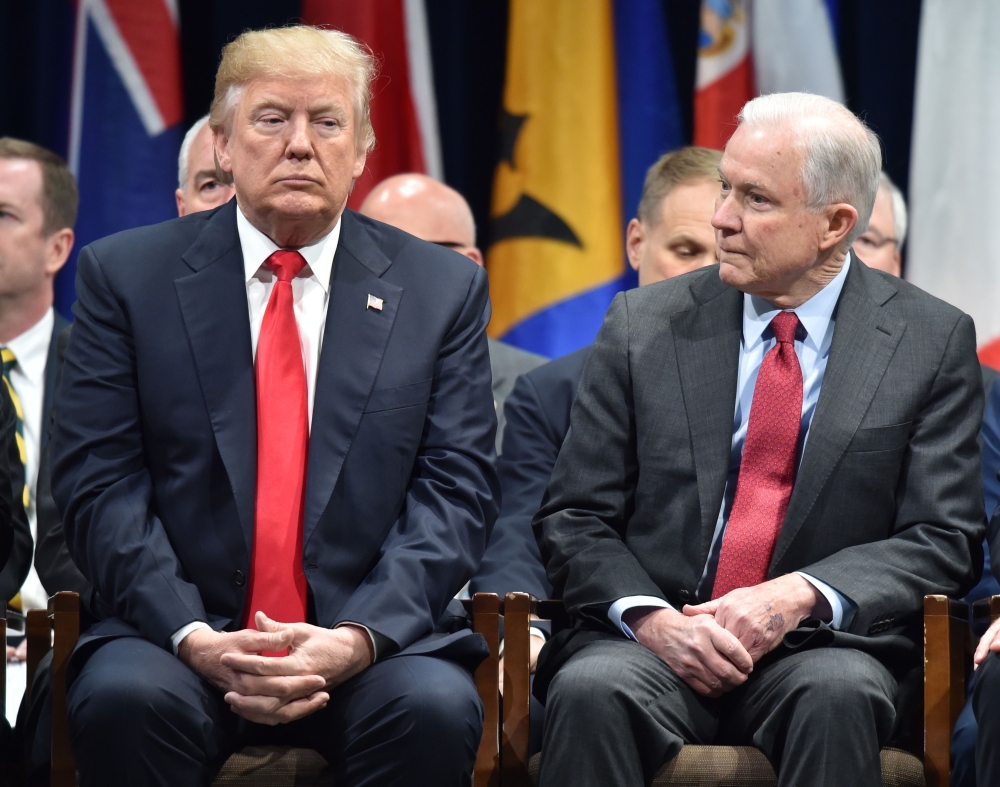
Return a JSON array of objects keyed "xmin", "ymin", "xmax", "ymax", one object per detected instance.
[{"xmin": 56, "ymin": 0, "xmax": 184, "ymax": 316}]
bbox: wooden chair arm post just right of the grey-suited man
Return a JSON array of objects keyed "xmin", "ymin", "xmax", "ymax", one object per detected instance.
[{"xmin": 924, "ymin": 596, "xmax": 971, "ymax": 787}]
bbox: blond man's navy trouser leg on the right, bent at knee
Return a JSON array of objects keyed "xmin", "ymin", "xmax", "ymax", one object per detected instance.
[{"xmin": 280, "ymin": 656, "xmax": 483, "ymax": 787}]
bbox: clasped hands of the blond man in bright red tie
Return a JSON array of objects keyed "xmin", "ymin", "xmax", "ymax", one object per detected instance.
[{"xmin": 177, "ymin": 612, "xmax": 374, "ymax": 725}]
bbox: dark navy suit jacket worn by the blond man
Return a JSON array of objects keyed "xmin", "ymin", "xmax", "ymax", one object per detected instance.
[{"xmin": 52, "ymin": 200, "xmax": 499, "ymax": 663}]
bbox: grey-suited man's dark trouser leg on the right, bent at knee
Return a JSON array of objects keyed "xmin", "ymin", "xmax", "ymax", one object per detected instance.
[{"xmin": 720, "ymin": 648, "xmax": 897, "ymax": 787}]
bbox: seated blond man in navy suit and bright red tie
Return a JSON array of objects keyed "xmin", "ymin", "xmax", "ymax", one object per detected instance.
[{"xmin": 52, "ymin": 27, "xmax": 498, "ymax": 785}]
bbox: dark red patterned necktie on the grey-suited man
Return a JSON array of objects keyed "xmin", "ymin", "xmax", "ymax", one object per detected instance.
[{"xmin": 712, "ymin": 312, "xmax": 802, "ymax": 599}]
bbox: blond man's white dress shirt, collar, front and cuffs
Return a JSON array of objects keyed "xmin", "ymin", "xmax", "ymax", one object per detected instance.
[{"xmin": 170, "ymin": 208, "xmax": 377, "ymax": 656}]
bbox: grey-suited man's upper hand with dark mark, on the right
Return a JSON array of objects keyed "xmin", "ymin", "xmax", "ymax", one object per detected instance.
[{"xmin": 683, "ymin": 574, "xmax": 832, "ymax": 664}]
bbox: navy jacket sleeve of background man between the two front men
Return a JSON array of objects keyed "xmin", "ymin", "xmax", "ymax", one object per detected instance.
[{"xmin": 469, "ymin": 346, "xmax": 590, "ymax": 598}]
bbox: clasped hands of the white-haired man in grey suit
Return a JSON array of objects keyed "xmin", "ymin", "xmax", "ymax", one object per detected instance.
[{"xmin": 623, "ymin": 574, "xmax": 831, "ymax": 697}]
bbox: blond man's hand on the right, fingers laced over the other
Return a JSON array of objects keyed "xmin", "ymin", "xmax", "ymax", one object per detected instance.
[{"xmin": 220, "ymin": 612, "xmax": 374, "ymax": 724}]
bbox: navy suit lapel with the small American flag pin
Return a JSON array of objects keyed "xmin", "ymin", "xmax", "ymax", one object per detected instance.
[{"xmin": 305, "ymin": 211, "xmax": 403, "ymax": 543}]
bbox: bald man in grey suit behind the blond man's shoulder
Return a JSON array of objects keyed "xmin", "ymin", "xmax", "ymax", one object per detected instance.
[{"xmin": 359, "ymin": 173, "xmax": 548, "ymax": 454}]
